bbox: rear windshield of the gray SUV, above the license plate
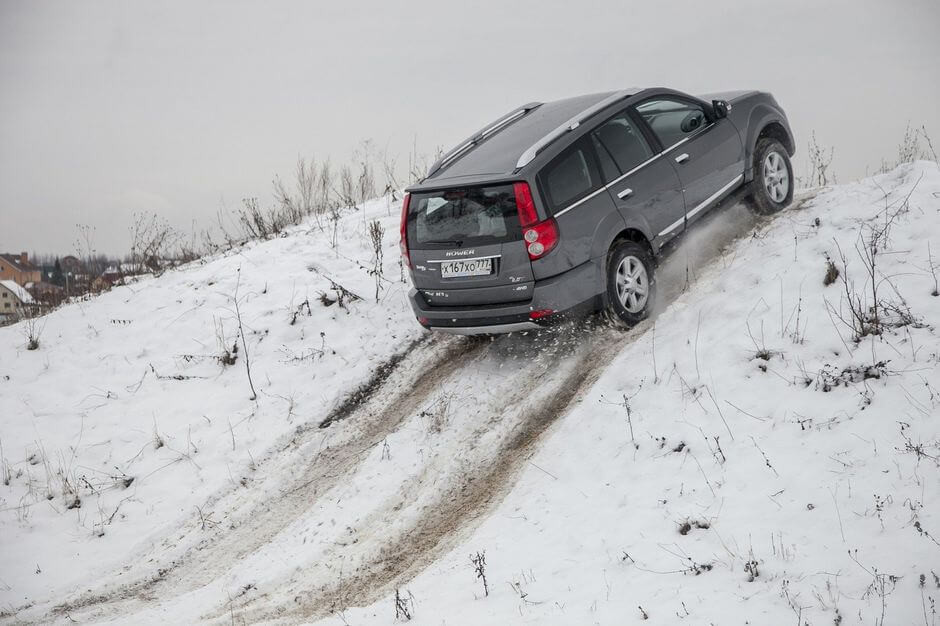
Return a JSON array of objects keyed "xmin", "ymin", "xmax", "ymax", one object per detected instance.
[{"xmin": 408, "ymin": 185, "xmax": 522, "ymax": 248}]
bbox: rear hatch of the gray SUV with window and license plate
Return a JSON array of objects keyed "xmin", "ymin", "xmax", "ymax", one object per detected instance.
[{"xmin": 402, "ymin": 183, "xmax": 534, "ymax": 307}]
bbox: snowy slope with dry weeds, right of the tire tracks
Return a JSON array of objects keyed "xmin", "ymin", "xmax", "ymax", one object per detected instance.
[{"xmin": 334, "ymin": 162, "xmax": 940, "ymax": 625}]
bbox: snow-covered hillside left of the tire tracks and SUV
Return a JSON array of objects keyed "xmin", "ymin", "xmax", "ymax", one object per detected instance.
[{"xmin": 0, "ymin": 198, "xmax": 421, "ymax": 610}]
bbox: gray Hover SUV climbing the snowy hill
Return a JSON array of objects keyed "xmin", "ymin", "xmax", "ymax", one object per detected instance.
[{"xmin": 401, "ymin": 88, "xmax": 795, "ymax": 334}]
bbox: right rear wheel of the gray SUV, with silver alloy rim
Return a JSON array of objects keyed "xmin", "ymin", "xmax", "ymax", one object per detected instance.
[{"xmin": 605, "ymin": 241, "xmax": 656, "ymax": 327}]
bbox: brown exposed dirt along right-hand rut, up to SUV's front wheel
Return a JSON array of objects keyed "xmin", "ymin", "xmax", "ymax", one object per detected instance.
[{"xmin": 258, "ymin": 198, "xmax": 792, "ymax": 621}]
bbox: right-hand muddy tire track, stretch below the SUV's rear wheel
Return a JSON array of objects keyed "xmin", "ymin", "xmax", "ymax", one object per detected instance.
[{"xmin": 229, "ymin": 323, "xmax": 650, "ymax": 622}]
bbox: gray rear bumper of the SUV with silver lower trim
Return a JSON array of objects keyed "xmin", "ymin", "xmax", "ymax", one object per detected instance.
[{"xmin": 408, "ymin": 255, "xmax": 603, "ymax": 335}]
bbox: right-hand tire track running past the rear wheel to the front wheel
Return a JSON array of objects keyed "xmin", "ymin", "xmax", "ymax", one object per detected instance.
[{"xmin": 213, "ymin": 199, "xmax": 800, "ymax": 622}]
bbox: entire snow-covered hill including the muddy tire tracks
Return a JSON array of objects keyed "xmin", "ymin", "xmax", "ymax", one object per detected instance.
[{"xmin": 0, "ymin": 162, "xmax": 940, "ymax": 626}]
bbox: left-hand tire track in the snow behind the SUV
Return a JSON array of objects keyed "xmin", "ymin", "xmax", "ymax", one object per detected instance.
[{"xmin": 40, "ymin": 335, "xmax": 482, "ymax": 622}]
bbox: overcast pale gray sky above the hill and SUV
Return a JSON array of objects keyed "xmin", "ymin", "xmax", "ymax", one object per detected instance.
[{"xmin": 0, "ymin": 0, "xmax": 940, "ymax": 254}]
